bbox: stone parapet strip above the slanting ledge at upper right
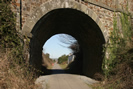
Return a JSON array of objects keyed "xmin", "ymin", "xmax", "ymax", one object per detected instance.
[{"xmin": 84, "ymin": 0, "xmax": 133, "ymax": 16}]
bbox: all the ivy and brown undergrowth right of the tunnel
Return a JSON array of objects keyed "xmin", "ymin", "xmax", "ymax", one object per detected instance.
[{"xmin": 96, "ymin": 8, "xmax": 133, "ymax": 89}]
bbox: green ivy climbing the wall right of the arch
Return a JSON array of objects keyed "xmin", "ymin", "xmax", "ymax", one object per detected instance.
[{"xmin": 102, "ymin": 13, "xmax": 133, "ymax": 78}]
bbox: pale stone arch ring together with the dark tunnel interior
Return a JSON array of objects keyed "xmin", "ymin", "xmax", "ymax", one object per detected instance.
[{"xmin": 23, "ymin": 0, "xmax": 107, "ymax": 76}]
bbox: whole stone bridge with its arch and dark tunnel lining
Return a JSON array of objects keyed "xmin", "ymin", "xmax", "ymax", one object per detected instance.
[{"xmin": 12, "ymin": 0, "xmax": 133, "ymax": 76}]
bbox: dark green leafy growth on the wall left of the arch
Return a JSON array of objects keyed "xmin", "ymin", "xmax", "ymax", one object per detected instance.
[{"xmin": 0, "ymin": 0, "xmax": 23, "ymax": 62}]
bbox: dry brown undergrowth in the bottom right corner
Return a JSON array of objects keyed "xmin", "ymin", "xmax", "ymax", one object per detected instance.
[{"xmin": 92, "ymin": 51, "xmax": 133, "ymax": 89}]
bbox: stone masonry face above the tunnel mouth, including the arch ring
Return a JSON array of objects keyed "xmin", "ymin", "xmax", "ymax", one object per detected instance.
[{"xmin": 12, "ymin": 0, "xmax": 133, "ymax": 41}]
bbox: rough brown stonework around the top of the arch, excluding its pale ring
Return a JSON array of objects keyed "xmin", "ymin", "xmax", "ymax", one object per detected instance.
[{"xmin": 12, "ymin": 0, "xmax": 133, "ymax": 34}]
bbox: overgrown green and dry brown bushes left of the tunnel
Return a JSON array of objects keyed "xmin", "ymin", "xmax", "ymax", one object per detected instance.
[{"xmin": 0, "ymin": 0, "xmax": 36, "ymax": 89}]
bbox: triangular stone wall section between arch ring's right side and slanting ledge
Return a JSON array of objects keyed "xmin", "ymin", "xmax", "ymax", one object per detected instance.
[{"xmin": 84, "ymin": 3, "xmax": 114, "ymax": 41}]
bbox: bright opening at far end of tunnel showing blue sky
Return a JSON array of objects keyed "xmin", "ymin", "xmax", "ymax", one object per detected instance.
[{"xmin": 42, "ymin": 34, "xmax": 79, "ymax": 72}]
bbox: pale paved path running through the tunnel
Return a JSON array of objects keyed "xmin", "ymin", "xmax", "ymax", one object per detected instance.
[{"xmin": 36, "ymin": 64, "xmax": 96, "ymax": 89}]
